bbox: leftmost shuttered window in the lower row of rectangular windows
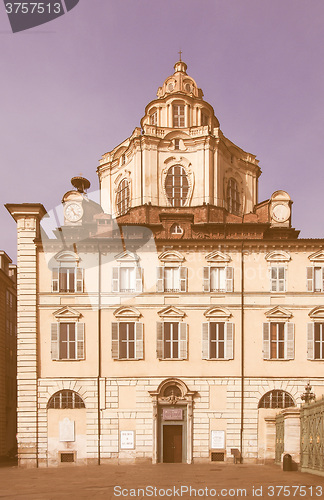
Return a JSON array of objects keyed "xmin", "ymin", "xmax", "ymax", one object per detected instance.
[{"xmin": 51, "ymin": 322, "xmax": 84, "ymax": 360}]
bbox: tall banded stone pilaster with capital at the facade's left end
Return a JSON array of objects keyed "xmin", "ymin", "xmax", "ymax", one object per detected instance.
[{"xmin": 6, "ymin": 203, "xmax": 46, "ymax": 467}]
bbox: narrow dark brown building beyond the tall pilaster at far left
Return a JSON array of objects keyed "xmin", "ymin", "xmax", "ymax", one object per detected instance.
[{"xmin": 0, "ymin": 251, "xmax": 17, "ymax": 460}]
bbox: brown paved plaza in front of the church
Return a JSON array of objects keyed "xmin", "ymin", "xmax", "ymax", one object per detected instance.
[{"xmin": 0, "ymin": 463, "xmax": 324, "ymax": 500}]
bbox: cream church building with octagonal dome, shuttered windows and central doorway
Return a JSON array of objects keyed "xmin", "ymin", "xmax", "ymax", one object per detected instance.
[{"xmin": 7, "ymin": 60, "xmax": 324, "ymax": 466}]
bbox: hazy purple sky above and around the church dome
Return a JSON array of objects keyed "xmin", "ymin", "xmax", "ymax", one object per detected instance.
[{"xmin": 0, "ymin": 0, "xmax": 324, "ymax": 261}]
